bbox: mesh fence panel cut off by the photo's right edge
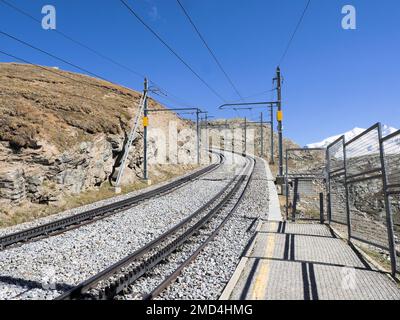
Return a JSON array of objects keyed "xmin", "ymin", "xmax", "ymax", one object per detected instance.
[{"xmin": 382, "ymin": 131, "xmax": 400, "ymax": 272}]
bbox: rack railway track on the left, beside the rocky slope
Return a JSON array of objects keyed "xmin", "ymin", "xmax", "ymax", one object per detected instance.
[{"xmin": 0, "ymin": 152, "xmax": 224, "ymax": 250}]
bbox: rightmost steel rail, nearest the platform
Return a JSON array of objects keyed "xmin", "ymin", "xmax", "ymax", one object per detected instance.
[{"xmin": 143, "ymin": 158, "xmax": 256, "ymax": 300}]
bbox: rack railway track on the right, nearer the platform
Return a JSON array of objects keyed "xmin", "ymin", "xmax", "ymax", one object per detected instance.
[{"xmin": 57, "ymin": 152, "xmax": 255, "ymax": 300}]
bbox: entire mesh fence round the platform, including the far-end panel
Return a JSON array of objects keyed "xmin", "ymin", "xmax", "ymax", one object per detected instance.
[{"xmin": 285, "ymin": 123, "xmax": 400, "ymax": 275}]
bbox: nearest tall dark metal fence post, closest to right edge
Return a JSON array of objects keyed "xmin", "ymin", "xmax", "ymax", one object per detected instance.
[{"xmin": 378, "ymin": 123, "xmax": 397, "ymax": 277}]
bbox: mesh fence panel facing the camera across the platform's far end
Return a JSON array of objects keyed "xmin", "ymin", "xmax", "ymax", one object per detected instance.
[{"xmin": 286, "ymin": 149, "xmax": 326, "ymax": 220}]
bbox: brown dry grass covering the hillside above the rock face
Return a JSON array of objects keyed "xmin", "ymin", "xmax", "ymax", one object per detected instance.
[{"xmin": 0, "ymin": 63, "xmax": 178, "ymax": 152}]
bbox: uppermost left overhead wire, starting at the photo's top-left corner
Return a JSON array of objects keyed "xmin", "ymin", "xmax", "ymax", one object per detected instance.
[{"xmin": 0, "ymin": 0, "xmax": 195, "ymax": 105}]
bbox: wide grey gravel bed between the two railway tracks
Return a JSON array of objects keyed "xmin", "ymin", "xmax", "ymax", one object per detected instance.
[{"xmin": 0, "ymin": 151, "xmax": 244, "ymax": 299}]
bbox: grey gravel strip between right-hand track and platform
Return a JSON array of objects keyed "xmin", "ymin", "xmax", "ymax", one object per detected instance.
[{"xmin": 158, "ymin": 159, "xmax": 268, "ymax": 300}]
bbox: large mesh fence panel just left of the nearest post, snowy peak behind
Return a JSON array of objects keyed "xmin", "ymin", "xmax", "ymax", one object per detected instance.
[{"xmin": 345, "ymin": 124, "xmax": 389, "ymax": 249}]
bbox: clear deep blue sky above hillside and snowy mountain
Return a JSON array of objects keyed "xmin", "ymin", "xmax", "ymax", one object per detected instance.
[{"xmin": 0, "ymin": 0, "xmax": 400, "ymax": 144}]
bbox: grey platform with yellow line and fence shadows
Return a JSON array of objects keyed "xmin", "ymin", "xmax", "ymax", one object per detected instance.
[{"xmin": 222, "ymin": 220, "xmax": 400, "ymax": 300}]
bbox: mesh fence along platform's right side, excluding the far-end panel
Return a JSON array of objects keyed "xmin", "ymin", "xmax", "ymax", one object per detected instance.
[{"xmin": 326, "ymin": 123, "xmax": 400, "ymax": 273}]
